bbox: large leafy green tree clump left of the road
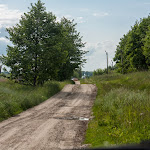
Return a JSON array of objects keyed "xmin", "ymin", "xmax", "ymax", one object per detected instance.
[{"xmin": 0, "ymin": 0, "xmax": 86, "ymax": 86}]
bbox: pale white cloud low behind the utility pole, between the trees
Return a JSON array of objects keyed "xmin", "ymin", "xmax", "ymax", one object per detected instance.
[{"xmin": 83, "ymin": 41, "xmax": 117, "ymax": 71}]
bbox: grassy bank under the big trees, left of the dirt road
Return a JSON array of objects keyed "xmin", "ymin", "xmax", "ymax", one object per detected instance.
[{"xmin": 0, "ymin": 78, "xmax": 71, "ymax": 121}]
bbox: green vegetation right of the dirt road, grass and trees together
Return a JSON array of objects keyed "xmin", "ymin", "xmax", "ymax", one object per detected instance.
[{"xmin": 82, "ymin": 12, "xmax": 150, "ymax": 147}]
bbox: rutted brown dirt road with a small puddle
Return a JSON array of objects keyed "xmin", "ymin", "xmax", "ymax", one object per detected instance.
[{"xmin": 0, "ymin": 83, "xmax": 97, "ymax": 150}]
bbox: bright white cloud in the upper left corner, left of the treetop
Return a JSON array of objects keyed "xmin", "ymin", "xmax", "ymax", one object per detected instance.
[{"xmin": 0, "ymin": 4, "xmax": 23, "ymax": 28}]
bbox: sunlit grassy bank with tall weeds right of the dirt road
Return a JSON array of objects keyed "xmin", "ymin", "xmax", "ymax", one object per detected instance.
[{"xmin": 82, "ymin": 72, "xmax": 150, "ymax": 147}]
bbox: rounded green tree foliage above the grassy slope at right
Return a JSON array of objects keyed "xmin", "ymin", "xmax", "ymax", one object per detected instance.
[{"xmin": 114, "ymin": 16, "xmax": 150, "ymax": 73}]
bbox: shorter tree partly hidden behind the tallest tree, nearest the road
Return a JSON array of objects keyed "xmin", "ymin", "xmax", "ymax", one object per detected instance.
[{"xmin": 57, "ymin": 18, "xmax": 87, "ymax": 81}]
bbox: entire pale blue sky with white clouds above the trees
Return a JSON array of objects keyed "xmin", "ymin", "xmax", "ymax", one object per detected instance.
[{"xmin": 0, "ymin": 0, "xmax": 150, "ymax": 71}]
